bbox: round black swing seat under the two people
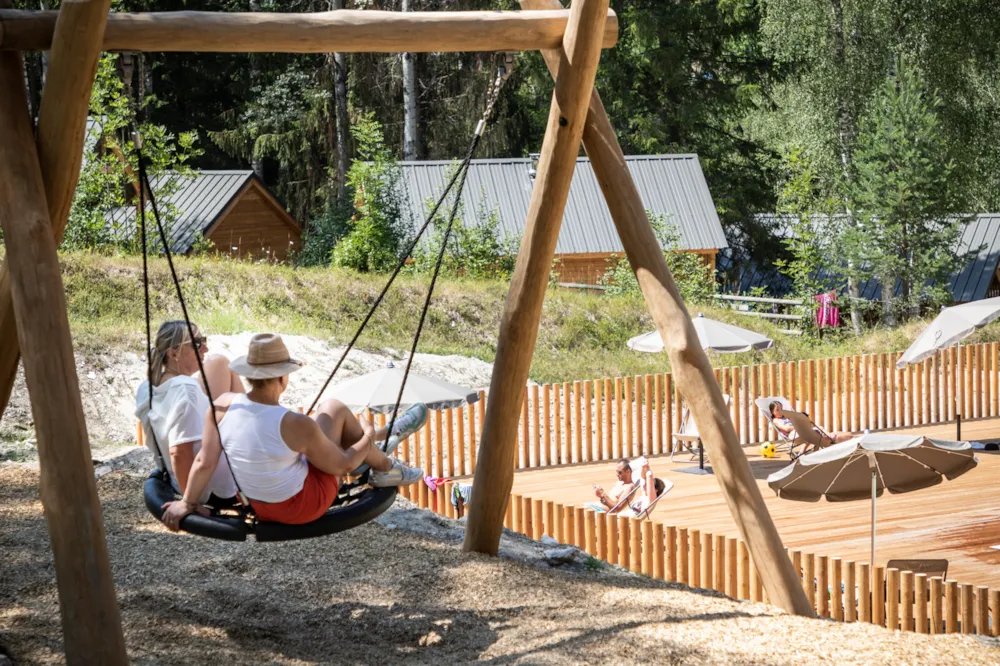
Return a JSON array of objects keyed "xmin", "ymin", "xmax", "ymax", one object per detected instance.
[{"xmin": 143, "ymin": 470, "xmax": 397, "ymax": 542}]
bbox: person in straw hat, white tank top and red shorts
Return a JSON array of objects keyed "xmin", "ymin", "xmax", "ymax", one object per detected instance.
[{"xmin": 162, "ymin": 333, "xmax": 427, "ymax": 530}]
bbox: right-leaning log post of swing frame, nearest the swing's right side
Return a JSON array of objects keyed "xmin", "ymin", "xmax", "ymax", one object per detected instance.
[{"xmin": 464, "ymin": 0, "xmax": 608, "ymax": 555}]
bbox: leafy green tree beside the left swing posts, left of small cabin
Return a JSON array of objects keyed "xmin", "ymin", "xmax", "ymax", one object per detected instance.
[{"xmin": 62, "ymin": 55, "xmax": 200, "ymax": 251}]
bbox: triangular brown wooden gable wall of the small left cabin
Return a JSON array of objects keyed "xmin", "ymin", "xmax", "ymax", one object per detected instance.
[{"xmin": 206, "ymin": 180, "xmax": 302, "ymax": 262}]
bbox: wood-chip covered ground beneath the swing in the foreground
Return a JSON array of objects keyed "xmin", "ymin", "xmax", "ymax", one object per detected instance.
[{"xmin": 0, "ymin": 451, "xmax": 1000, "ymax": 666}]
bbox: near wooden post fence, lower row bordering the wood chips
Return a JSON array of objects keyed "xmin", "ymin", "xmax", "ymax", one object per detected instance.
[{"xmin": 401, "ymin": 481, "xmax": 1000, "ymax": 636}]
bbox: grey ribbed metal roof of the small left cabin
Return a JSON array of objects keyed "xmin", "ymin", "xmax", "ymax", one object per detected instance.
[{"xmin": 105, "ymin": 170, "xmax": 253, "ymax": 254}]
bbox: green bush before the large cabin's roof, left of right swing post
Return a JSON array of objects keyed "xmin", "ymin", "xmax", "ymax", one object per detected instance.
[{"xmin": 412, "ymin": 187, "xmax": 520, "ymax": 280}]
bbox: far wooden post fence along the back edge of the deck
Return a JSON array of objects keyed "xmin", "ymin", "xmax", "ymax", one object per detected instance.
[{"xmin": 386, "ymin": 343, "xmax": 1000, "ymax": 477}]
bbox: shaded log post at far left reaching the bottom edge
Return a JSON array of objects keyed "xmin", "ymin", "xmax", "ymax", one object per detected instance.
[{"xmin": 0, "ymin": 27, "xmax": 127, "ymax": 664}]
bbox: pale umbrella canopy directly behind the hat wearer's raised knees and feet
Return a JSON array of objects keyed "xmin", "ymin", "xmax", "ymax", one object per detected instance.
[{"xmin": 328, "ymin": 361, "xmax": 479, "ymax": 414}]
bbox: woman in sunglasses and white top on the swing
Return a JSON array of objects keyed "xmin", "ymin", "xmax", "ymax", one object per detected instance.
[{"xmin": 135, "ymin": 320, "xmax": 246, "ymax": 504}]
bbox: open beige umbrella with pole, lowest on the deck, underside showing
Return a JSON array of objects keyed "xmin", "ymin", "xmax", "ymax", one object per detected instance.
[{"xmin": 767, "ymin": 434, "xmax": 978, "ymax": 567}]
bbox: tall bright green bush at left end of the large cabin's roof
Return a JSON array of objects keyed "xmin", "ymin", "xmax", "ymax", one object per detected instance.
[{"xmin": 330, "ymin": 114, "xmax": 410, "ymax": 272}]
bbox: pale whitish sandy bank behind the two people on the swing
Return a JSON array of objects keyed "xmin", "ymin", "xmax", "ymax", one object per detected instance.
[{"xmin": 0, "ymin": 333, "xmax": 493, "ymax": 461}]
